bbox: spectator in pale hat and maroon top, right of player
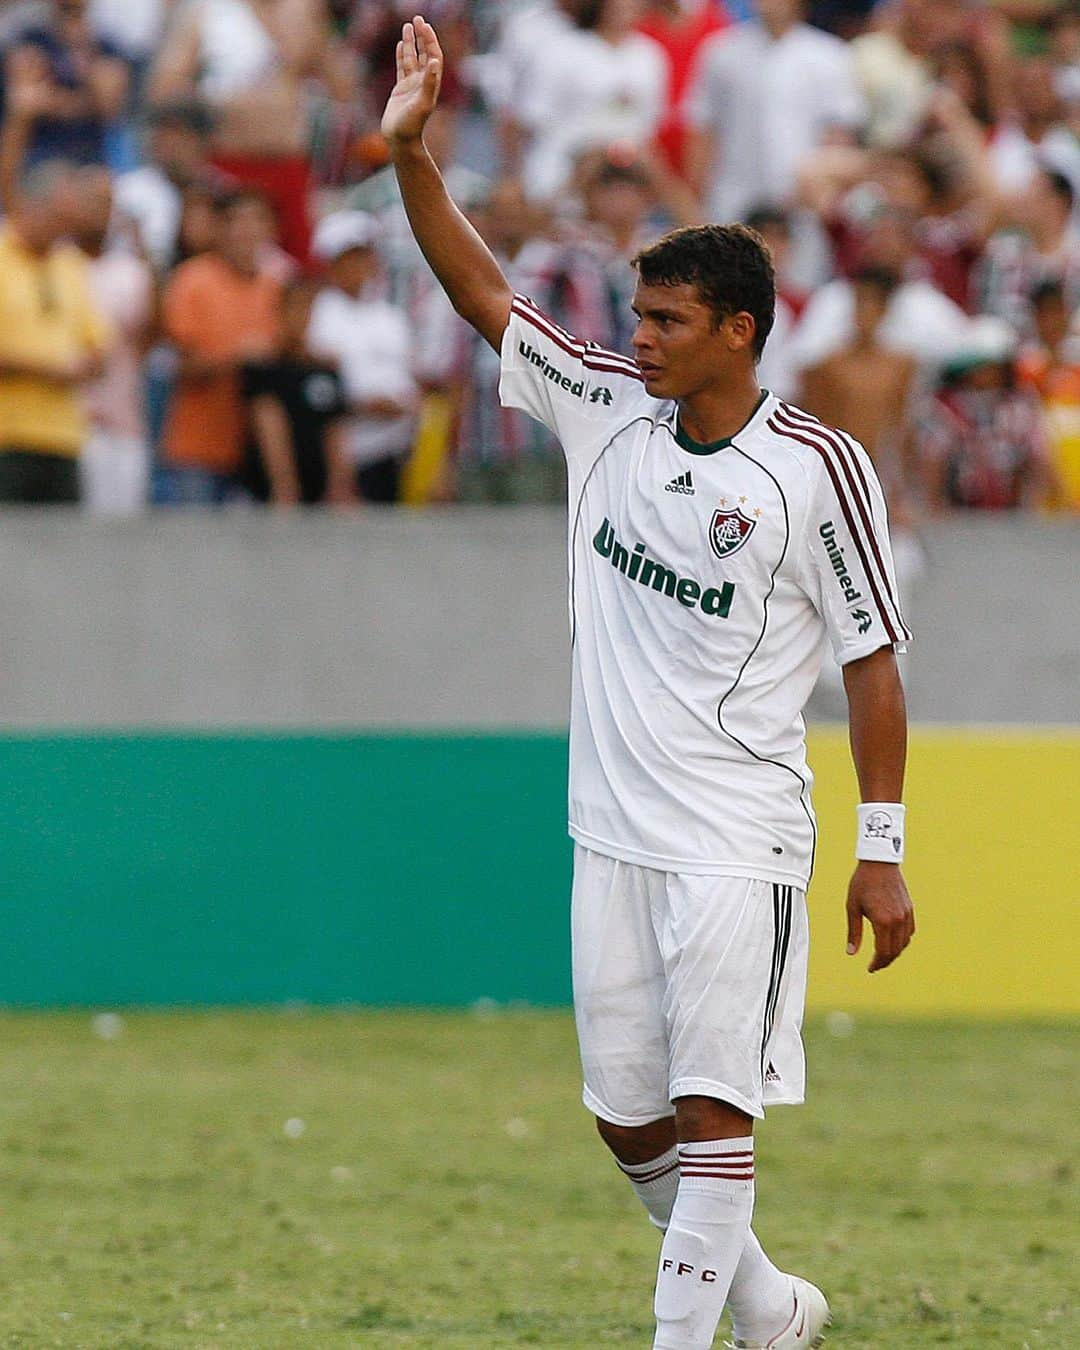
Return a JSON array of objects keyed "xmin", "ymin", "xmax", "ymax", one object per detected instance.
[{"xmin": 915, "ymin": 316, "xmax": 1050, "ymax": 513}]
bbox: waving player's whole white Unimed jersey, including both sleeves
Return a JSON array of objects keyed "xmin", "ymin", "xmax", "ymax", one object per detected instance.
[{"xmin": 500, "ymin": 296, "xmax": 911, "ymax": 888}]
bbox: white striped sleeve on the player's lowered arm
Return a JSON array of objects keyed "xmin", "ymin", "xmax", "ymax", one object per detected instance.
[{"xmin": 801, "ymin": 428, "xmax": 911, "ymax": 666}]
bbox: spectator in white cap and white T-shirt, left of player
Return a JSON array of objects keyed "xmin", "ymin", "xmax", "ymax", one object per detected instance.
[{"xmin": 308, "ymin": 211, "xmax": 420, "ymax": 502}]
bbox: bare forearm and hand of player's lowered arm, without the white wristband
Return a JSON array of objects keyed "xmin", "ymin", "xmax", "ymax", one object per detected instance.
[{"xmin": 844, "ymin": 647, "xmax": 915, "ymax": 971}]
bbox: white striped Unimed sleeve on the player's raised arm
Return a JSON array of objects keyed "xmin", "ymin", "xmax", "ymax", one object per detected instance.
[{"xmin": 498, "ymin": 296, "xmax": 659, "ymax": 459}]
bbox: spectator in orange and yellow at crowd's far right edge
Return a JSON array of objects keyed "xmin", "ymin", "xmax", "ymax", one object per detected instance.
[{"xmin": 1019, "ymin": 281, "xmax": 1080, "ymax": 512}]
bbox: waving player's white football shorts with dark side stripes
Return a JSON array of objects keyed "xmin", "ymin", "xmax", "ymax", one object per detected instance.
[{"xmin": 572, "ymin": 844, "xmax": 809, "ymax": 1126}]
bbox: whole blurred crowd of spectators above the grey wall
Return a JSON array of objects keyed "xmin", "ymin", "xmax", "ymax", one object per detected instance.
[{"xmin": 0, "ymin": 0, "xmax": 1080, "ymax": 515}]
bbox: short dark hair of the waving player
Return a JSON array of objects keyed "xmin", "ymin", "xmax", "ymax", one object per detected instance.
[{"xmin": 633, "ymin": 225, "xmax": 776, "ymax": 358}]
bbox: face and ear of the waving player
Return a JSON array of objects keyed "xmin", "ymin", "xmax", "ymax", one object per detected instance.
[{"xmin": 633, "ymin": 282, "xmax": 753, "ymax": 398}]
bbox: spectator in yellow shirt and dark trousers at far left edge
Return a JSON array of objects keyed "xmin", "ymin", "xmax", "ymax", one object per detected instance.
[{"xmin": 0, "ymin": 162, "xmax": 108, "ymax": 504}]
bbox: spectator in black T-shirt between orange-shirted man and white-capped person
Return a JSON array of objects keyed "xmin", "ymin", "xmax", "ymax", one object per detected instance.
[{"xmin": 242, "ymin": 278, "xmax": 355, "ymax": 506}]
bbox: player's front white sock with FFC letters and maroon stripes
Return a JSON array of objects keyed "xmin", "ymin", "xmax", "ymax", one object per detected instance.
[{"xmin": 653, "ymin": 1138, "xmax": 753, "ymax": 1350}]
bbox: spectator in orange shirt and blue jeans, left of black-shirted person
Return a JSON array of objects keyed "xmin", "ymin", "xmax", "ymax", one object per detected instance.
[{"xmin": 163, "ymin": 190, "xmax": 281, "ymax": 504}]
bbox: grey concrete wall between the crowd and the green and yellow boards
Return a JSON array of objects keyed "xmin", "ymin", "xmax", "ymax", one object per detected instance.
[{"xmin": 0, "ymin": 509, "xmax": 1080, "ymax": 729}]
